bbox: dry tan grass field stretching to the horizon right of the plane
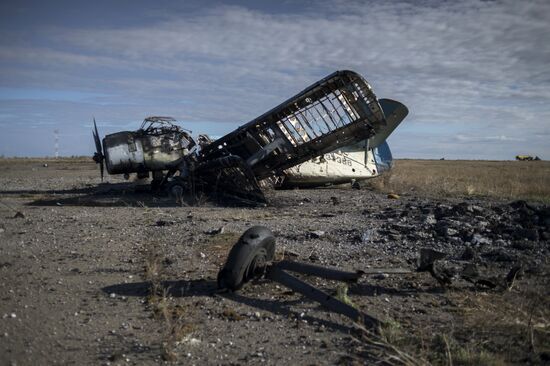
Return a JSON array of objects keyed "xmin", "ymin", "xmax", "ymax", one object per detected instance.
[{"xmin": 371, "ymin": 160, "xmax": 550, "ymax": 202}]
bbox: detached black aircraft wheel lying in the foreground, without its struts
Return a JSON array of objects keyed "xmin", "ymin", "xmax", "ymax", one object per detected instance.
[{"xmin": 218, "ymin": 226, "xmax": 275, "ymax": 291}]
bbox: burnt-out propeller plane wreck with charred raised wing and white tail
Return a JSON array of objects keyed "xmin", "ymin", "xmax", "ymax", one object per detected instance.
[{"xmin": 93, "ymin": 71, "xmax": 408, "ymax": 205}]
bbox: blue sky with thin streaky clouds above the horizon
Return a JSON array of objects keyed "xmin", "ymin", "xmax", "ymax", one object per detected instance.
[{"xmin": 0, "ymin": 0, "xmax": 550, "ymax": 160}]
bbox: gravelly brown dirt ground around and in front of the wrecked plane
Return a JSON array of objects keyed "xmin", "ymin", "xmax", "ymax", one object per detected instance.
[{"xmin": 0, "ymin": 159, "xmax": 550, "ymax": 365}]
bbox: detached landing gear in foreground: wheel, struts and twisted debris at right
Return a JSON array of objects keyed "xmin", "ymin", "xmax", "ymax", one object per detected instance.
[{"xmin": 217, "ymin": 226, "xmax": 522, "ymax": 331}]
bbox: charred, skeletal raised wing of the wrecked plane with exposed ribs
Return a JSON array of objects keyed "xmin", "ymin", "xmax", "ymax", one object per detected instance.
[{"xmin": 200, "ymin": 70, "xmax": 386, "ymax": 180}]
